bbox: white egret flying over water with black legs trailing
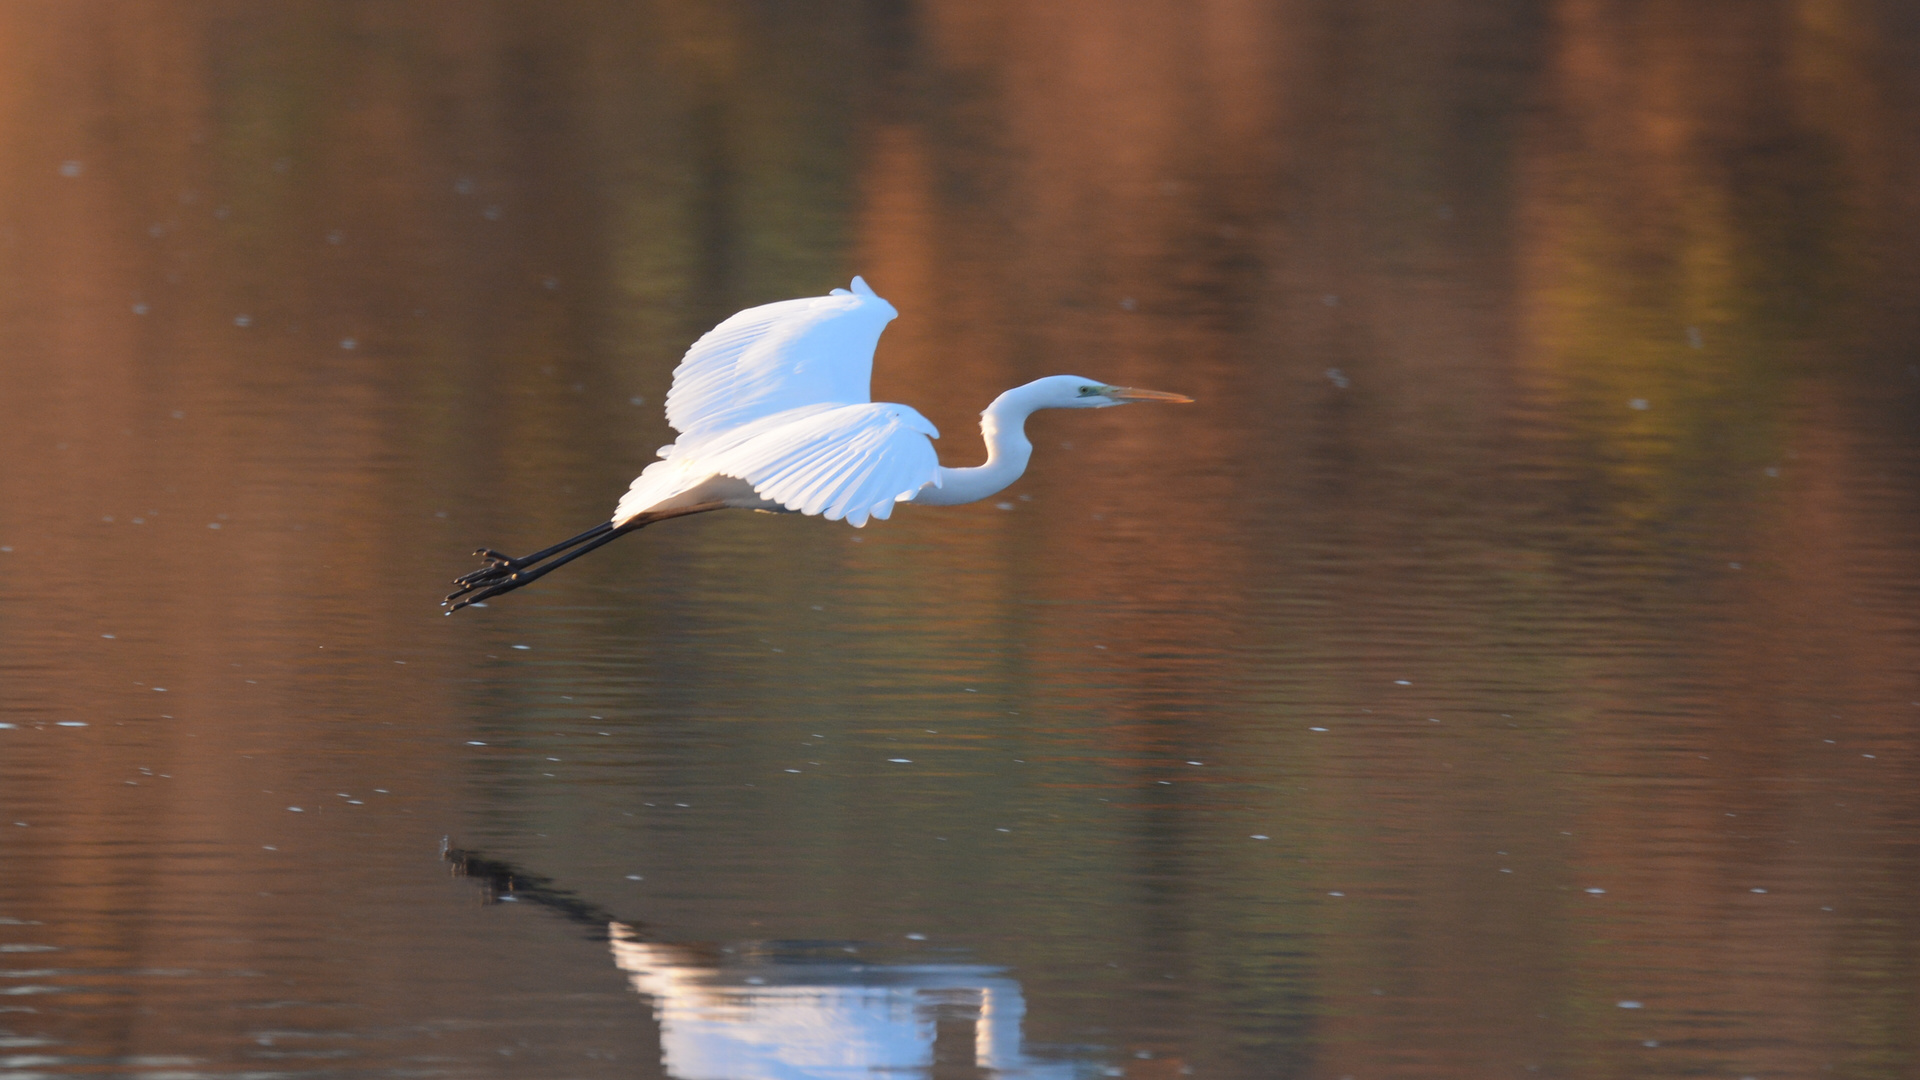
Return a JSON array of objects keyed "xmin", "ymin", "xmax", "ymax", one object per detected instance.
[{"xmin": 445, "ymin": 277, "xmax": 1192, "ymax": 615}]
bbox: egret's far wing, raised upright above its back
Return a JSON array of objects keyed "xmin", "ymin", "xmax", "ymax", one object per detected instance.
[{"xmin": 662, "ymin": 277, "xmax": 897, "ymax": 447}]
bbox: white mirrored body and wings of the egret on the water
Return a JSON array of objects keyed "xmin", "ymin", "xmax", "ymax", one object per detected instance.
[{"xmin": 609, "ymin": 922, "xmax": 1079, "ymax": 1080}]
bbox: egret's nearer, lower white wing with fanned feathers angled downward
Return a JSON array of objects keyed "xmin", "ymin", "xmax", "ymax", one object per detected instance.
[{"xmin": 701, "ymin": 402, "xmax": 941, "ymax": 527}]
